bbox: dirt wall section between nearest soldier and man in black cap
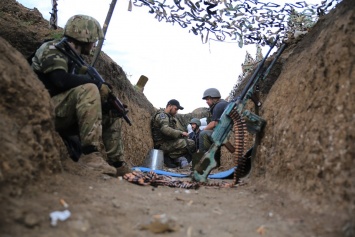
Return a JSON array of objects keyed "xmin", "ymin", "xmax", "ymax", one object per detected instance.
[{"xmin": 87, "ymin": 53, "xmax": 155, "ymax": 166}]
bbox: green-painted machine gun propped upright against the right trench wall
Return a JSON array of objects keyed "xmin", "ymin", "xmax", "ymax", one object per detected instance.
[{"xmin": 192, "ymin": 37, "xmax": 286, "ymax": 182}]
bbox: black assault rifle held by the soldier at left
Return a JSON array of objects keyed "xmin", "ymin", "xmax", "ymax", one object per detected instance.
[{"xmin": 55, "ymin": 37, "xmax": 132, "ymax": 126}]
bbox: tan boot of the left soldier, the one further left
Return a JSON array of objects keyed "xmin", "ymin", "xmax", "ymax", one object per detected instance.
[{"xmin": 79, "ymin": 152, "xmax": 117, "ymax": 176}]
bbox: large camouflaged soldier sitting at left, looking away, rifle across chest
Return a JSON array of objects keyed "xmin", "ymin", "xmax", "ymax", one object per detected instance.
[{"xmin": 32, "ymin": 15, "xmax": 130, "ymax": 176}]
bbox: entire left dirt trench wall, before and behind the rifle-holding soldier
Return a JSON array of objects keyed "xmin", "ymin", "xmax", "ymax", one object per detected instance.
[{"xmin": 0, "ymin": 0, "xmax": 154, "ymax": 187}]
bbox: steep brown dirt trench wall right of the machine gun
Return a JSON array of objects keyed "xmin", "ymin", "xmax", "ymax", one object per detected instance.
[{"xmin": 253, "ymin": 0, "xmax": 355, "ymax": 213}]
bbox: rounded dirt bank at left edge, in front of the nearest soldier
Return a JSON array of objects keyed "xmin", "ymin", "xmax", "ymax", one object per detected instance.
[{"xmin": 0, "ymin": 37, "xmax": 61, "ymax": 194}]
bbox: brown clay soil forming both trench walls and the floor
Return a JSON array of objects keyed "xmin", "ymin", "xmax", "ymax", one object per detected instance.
[{"xmin": 0, "ymin": 0, "xmax": 355, "ymax": 237}]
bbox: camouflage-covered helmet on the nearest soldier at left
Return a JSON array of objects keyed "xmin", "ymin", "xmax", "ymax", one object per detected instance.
[{"xmin": 64, "ymin": 15, "xmax": 104, "ymax": 43}]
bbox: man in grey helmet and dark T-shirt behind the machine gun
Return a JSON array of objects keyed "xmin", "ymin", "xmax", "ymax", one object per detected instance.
[{"xmin": 199, "ymin": 88, "xmax": 228, "ymax": 167}]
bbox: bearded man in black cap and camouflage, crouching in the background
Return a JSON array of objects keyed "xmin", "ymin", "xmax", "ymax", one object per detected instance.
[{"xmin": 151, "ymin": 99, "xmax": 195, "ymax": 168}]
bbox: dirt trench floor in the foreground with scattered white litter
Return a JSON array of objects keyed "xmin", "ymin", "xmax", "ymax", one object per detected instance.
[{"xmin": 0, "ymin": 168, "xmax": 340, "ymax": 237}]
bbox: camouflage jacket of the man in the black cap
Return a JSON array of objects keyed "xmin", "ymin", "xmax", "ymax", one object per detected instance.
[{"xmin": 151, "ymin": 109, "xmax": 183, "ymax": 145}]
